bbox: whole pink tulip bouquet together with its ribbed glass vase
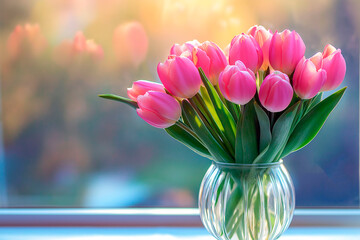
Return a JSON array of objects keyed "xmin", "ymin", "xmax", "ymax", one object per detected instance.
[{"xmin": 100, "ymin": 26, "xmax": 346, "ymax": 240}]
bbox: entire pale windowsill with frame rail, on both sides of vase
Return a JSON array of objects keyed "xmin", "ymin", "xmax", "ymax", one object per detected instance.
[{"xmin": 0, "ymin": 208, "xmax": 360, "ymax": 240}]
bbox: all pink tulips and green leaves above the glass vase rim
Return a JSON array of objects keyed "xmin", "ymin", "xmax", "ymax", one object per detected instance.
[{"xmin": 100, "ymin": 26, "xmax": 346, "ymax": 164}]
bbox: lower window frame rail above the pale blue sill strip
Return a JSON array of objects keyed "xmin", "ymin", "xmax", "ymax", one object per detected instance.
[{"xmin": 0, "ymin": 208, "xmax": 360, "ymax": 229}]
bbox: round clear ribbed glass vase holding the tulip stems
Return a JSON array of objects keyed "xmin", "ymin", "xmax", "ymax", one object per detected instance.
[{"xmin": 199, "ymin": 161, "xmax": 295, "ymax": 240}]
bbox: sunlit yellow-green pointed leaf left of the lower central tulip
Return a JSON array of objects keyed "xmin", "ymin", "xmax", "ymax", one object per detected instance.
[{"xmin": 199, "ymin": 68, "xmax": 236, "ymax": 146}]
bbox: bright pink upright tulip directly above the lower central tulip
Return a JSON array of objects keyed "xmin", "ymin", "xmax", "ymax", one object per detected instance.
[{"xmin": 229, "ymin": 33, "xmax": 263, "ymax": 72}]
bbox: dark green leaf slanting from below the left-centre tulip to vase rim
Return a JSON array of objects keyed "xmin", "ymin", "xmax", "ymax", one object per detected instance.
[{"xmin": 181, "ymin": 100, "xmax": 234, "ymax": 163}]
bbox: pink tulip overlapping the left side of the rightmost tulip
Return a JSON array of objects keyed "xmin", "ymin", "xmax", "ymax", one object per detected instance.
[{"xmin": 293, "ymin": 53, "xmax": 326, "ymax": 99}]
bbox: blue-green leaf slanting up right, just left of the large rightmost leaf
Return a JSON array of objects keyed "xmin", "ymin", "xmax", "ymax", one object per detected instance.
[{"xmin": 254, "ymin": 102, "xmax": 300, "ymax": 163}]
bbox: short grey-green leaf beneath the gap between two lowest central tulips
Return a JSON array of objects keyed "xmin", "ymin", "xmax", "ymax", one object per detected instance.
[{"xmin": 254, "ymin": 102, "xmax": 271, "ymax": 152}]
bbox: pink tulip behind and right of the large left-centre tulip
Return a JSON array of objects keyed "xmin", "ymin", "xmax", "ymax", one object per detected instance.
[{"xmin": 192, "ymin": 41, "xmax": 228, "ymax": 85}]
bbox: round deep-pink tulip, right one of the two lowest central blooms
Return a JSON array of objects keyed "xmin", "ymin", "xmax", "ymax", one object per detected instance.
[{"xmin": 259, "ymin": 71, "xmax": 293, "ymax": 112}]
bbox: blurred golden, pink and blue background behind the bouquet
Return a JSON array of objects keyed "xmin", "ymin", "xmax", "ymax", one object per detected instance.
[{"xmin": 0, "ymin": 0, "xmax": 360, "ymax": 207}]
